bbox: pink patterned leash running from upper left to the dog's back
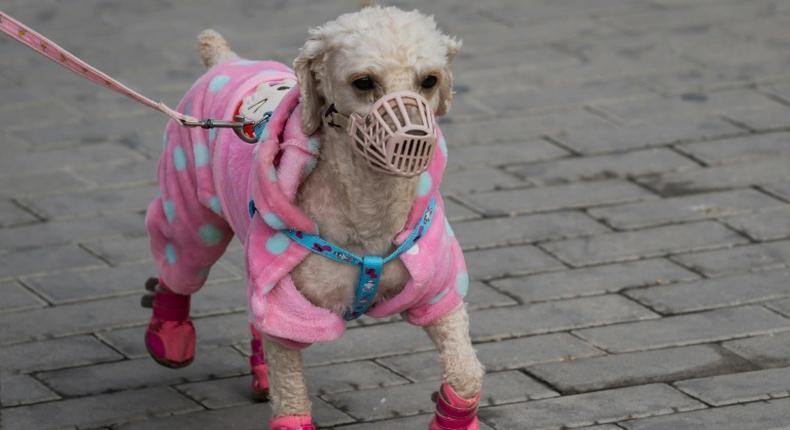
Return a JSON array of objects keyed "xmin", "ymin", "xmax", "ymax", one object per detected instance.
[{"xmin": 0, "ymin": 11, "xmax": 254, "ymax": 134}]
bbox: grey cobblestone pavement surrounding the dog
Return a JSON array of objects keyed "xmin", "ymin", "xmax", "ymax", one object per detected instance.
[{"xmin": 0, "ymin": 0, "xmax": 790, "ymax": 430}]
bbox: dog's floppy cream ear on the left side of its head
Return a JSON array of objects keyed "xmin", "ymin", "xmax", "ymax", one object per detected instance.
[{"xmin": 294, "ymin": 33, "xmax": 327, "ymax": 136}]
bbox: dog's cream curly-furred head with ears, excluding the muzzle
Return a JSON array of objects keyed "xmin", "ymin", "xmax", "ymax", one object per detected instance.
[{"xmin": 294, "ymin": 6, "xmax": 461, "ymax": 135}]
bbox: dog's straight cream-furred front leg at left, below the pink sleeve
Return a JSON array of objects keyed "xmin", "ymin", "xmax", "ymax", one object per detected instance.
[{"xmin": 264, "ymin": 337, "xmax": 312, "ymax": 429}]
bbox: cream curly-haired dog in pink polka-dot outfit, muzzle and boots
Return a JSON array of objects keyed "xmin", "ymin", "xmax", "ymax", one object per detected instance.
[{"xmin": 145, "ymin": 6, "xmax": 484, "ymax": 430}]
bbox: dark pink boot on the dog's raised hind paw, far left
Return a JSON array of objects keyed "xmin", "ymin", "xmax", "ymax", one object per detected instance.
[{"xmin": 142, "ymin": 278, "xmax": 195, "ymax": 368}]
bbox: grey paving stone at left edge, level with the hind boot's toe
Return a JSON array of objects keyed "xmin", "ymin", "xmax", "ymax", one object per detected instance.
[{"xmin": 0, "ymin": 336, "xmax": 123, "ymax": 372}]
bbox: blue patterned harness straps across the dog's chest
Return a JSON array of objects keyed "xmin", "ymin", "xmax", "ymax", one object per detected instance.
[{"xmin": 250, "ymin": 198, "xmax": 436, "ymax": 321}]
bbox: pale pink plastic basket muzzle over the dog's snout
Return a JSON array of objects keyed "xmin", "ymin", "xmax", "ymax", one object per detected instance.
[{"xmin": 346, "ymin": 91, "xmax": 436, "ymax": 177}]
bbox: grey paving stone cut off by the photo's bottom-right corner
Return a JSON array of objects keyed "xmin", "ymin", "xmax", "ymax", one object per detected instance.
[{"xmin": 622, "ymin": 399, "xmax": 790, "ymax": 430}]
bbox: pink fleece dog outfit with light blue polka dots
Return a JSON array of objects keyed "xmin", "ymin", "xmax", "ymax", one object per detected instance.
[{"xmin": 146, "ymin": 60, "xmax": 469, "ymax": 346}]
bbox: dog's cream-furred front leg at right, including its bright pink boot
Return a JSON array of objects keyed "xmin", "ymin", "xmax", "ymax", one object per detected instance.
[{"xmin": 425, "ymin": 306, "xmax": 484, "ymax": 430}]
